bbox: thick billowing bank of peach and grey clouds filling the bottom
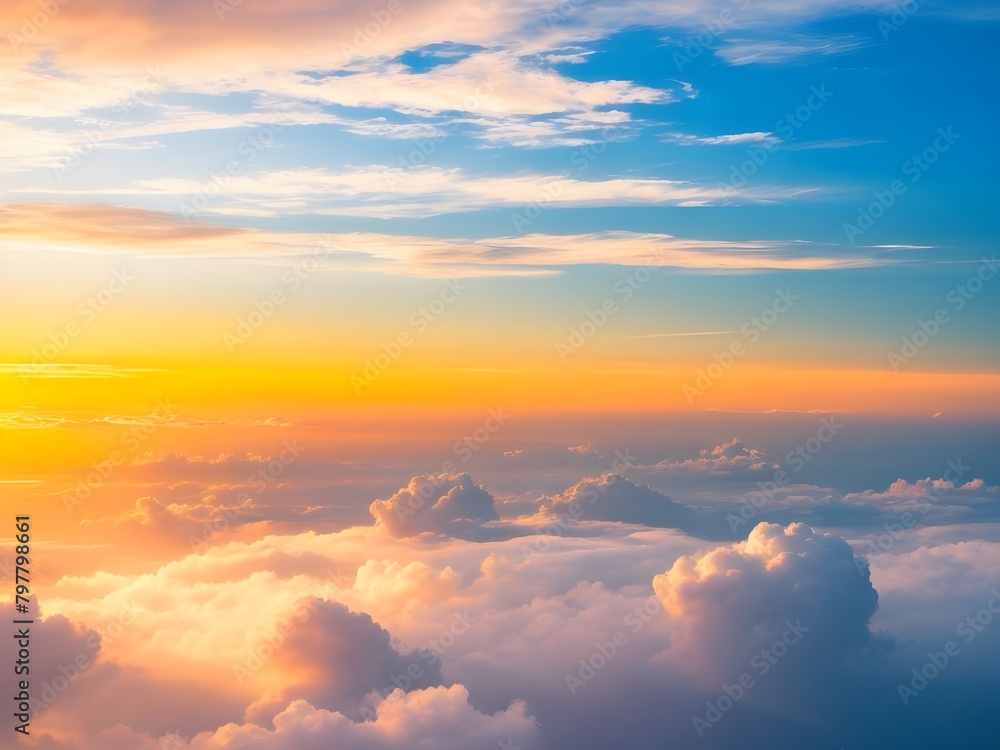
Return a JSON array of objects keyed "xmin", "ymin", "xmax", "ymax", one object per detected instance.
[{"xmin": 19, "ymin": 500, "xmax": 997, "ymax": 750}]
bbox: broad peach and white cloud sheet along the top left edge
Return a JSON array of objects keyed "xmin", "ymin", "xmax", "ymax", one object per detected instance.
[{"xmin": 0, "ymin": 0, "xmax": 908, "ymax": 151}]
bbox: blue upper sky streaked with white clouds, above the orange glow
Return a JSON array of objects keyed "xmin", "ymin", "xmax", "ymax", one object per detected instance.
[{"xmin": 0, "ymin": 1, "xmax": 1000, "ymax": 402}]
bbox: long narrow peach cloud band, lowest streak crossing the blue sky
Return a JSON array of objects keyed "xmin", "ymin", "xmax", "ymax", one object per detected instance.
[{"xmin": 0, "ymin": 206, "xmax": 893, "ymax": 278}]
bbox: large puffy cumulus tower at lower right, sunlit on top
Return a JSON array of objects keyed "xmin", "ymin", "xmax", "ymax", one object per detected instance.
[{"xmin": 653, "ymin": 523, "xmax": 878, "ymax": 680}]
